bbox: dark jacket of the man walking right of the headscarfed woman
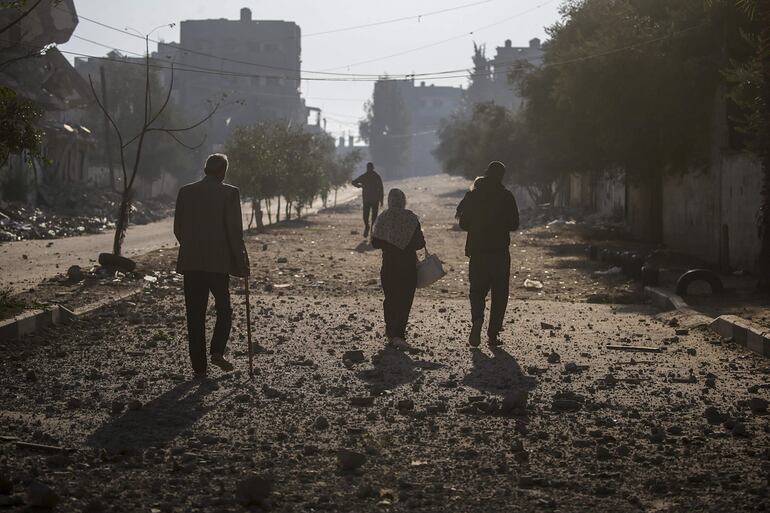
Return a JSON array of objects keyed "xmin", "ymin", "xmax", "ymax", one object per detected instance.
[{"xmin": 457, "ymin": 178, "xmax": 519, "ymax": 256}]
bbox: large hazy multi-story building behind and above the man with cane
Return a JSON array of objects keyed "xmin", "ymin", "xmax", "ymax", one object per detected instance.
[{"xmin": 171, "ymin": 8, "xmax": 307, "ymax": 150}]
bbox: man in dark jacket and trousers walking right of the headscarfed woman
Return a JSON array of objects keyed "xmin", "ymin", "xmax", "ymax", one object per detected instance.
[{"xmin": 457, "ymin": 162, "xmax": 519, "ymax": 347}]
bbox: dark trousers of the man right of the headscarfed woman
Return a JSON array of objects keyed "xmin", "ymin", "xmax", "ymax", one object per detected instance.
[{"xmin": 469, "ymin": 251, "xmax": 511, "ymax": 336}]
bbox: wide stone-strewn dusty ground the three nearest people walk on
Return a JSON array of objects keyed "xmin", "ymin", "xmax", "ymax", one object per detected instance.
[{"xmin": 0, "ymin": 174, "xmax": 770, "ymax": 512}]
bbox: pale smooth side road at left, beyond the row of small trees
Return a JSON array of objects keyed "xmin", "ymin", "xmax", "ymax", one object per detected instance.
[{"xmin": 0, "ymin": 187, "xmax": 360, "ymax": 292}]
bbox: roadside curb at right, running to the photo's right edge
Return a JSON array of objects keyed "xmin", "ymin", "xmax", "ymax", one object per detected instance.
[{"xmin": 644, "ymin": 287, "xmax": 770, "ymax": 357}]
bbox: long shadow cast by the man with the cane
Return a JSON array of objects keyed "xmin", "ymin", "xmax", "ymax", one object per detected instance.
[{"xmin": 86, "ymin": 381, "xmax": 217, "ymax": 450}]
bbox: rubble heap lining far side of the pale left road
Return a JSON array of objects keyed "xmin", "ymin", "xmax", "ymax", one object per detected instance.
[{"xmin": 0, "ymin": 186, "xmax": 173, "ymax": 242}]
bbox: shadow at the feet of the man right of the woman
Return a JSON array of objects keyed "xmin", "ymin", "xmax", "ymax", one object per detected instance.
[{"xmin": 463, "ymin": 347, "xmax": 537, "ymax": 397}]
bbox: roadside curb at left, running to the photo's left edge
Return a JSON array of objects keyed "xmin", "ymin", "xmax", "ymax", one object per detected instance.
[{"xmin": 0, "ymin": 287, "xmax": 143, "ymax": 342}]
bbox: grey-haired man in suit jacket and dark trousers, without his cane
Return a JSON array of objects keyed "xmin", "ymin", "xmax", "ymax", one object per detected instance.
[{"xmin": 174, "ymin": 153, "xmax": 249, "ymax": 378}]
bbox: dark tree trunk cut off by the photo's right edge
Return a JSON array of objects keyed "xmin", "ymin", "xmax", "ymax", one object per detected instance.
[{"xmin": 757, "ymin": 0, "xmax": 770, "ymax": 293}]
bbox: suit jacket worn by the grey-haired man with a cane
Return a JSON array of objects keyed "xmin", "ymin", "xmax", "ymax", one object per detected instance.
[{"xmin": 174, "ymin": 176, "xmax": 248, "ymax": 276}]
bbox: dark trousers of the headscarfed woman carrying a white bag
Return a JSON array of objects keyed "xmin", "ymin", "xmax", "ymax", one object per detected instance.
[{"xmin": 380, "ymin": 265, "xmax": 417, "ymax": 338}]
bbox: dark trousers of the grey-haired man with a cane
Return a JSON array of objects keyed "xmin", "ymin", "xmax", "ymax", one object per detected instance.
[{"xmin": 184, "ymin": 271, "xmax": 233, "ymax": 372}]
